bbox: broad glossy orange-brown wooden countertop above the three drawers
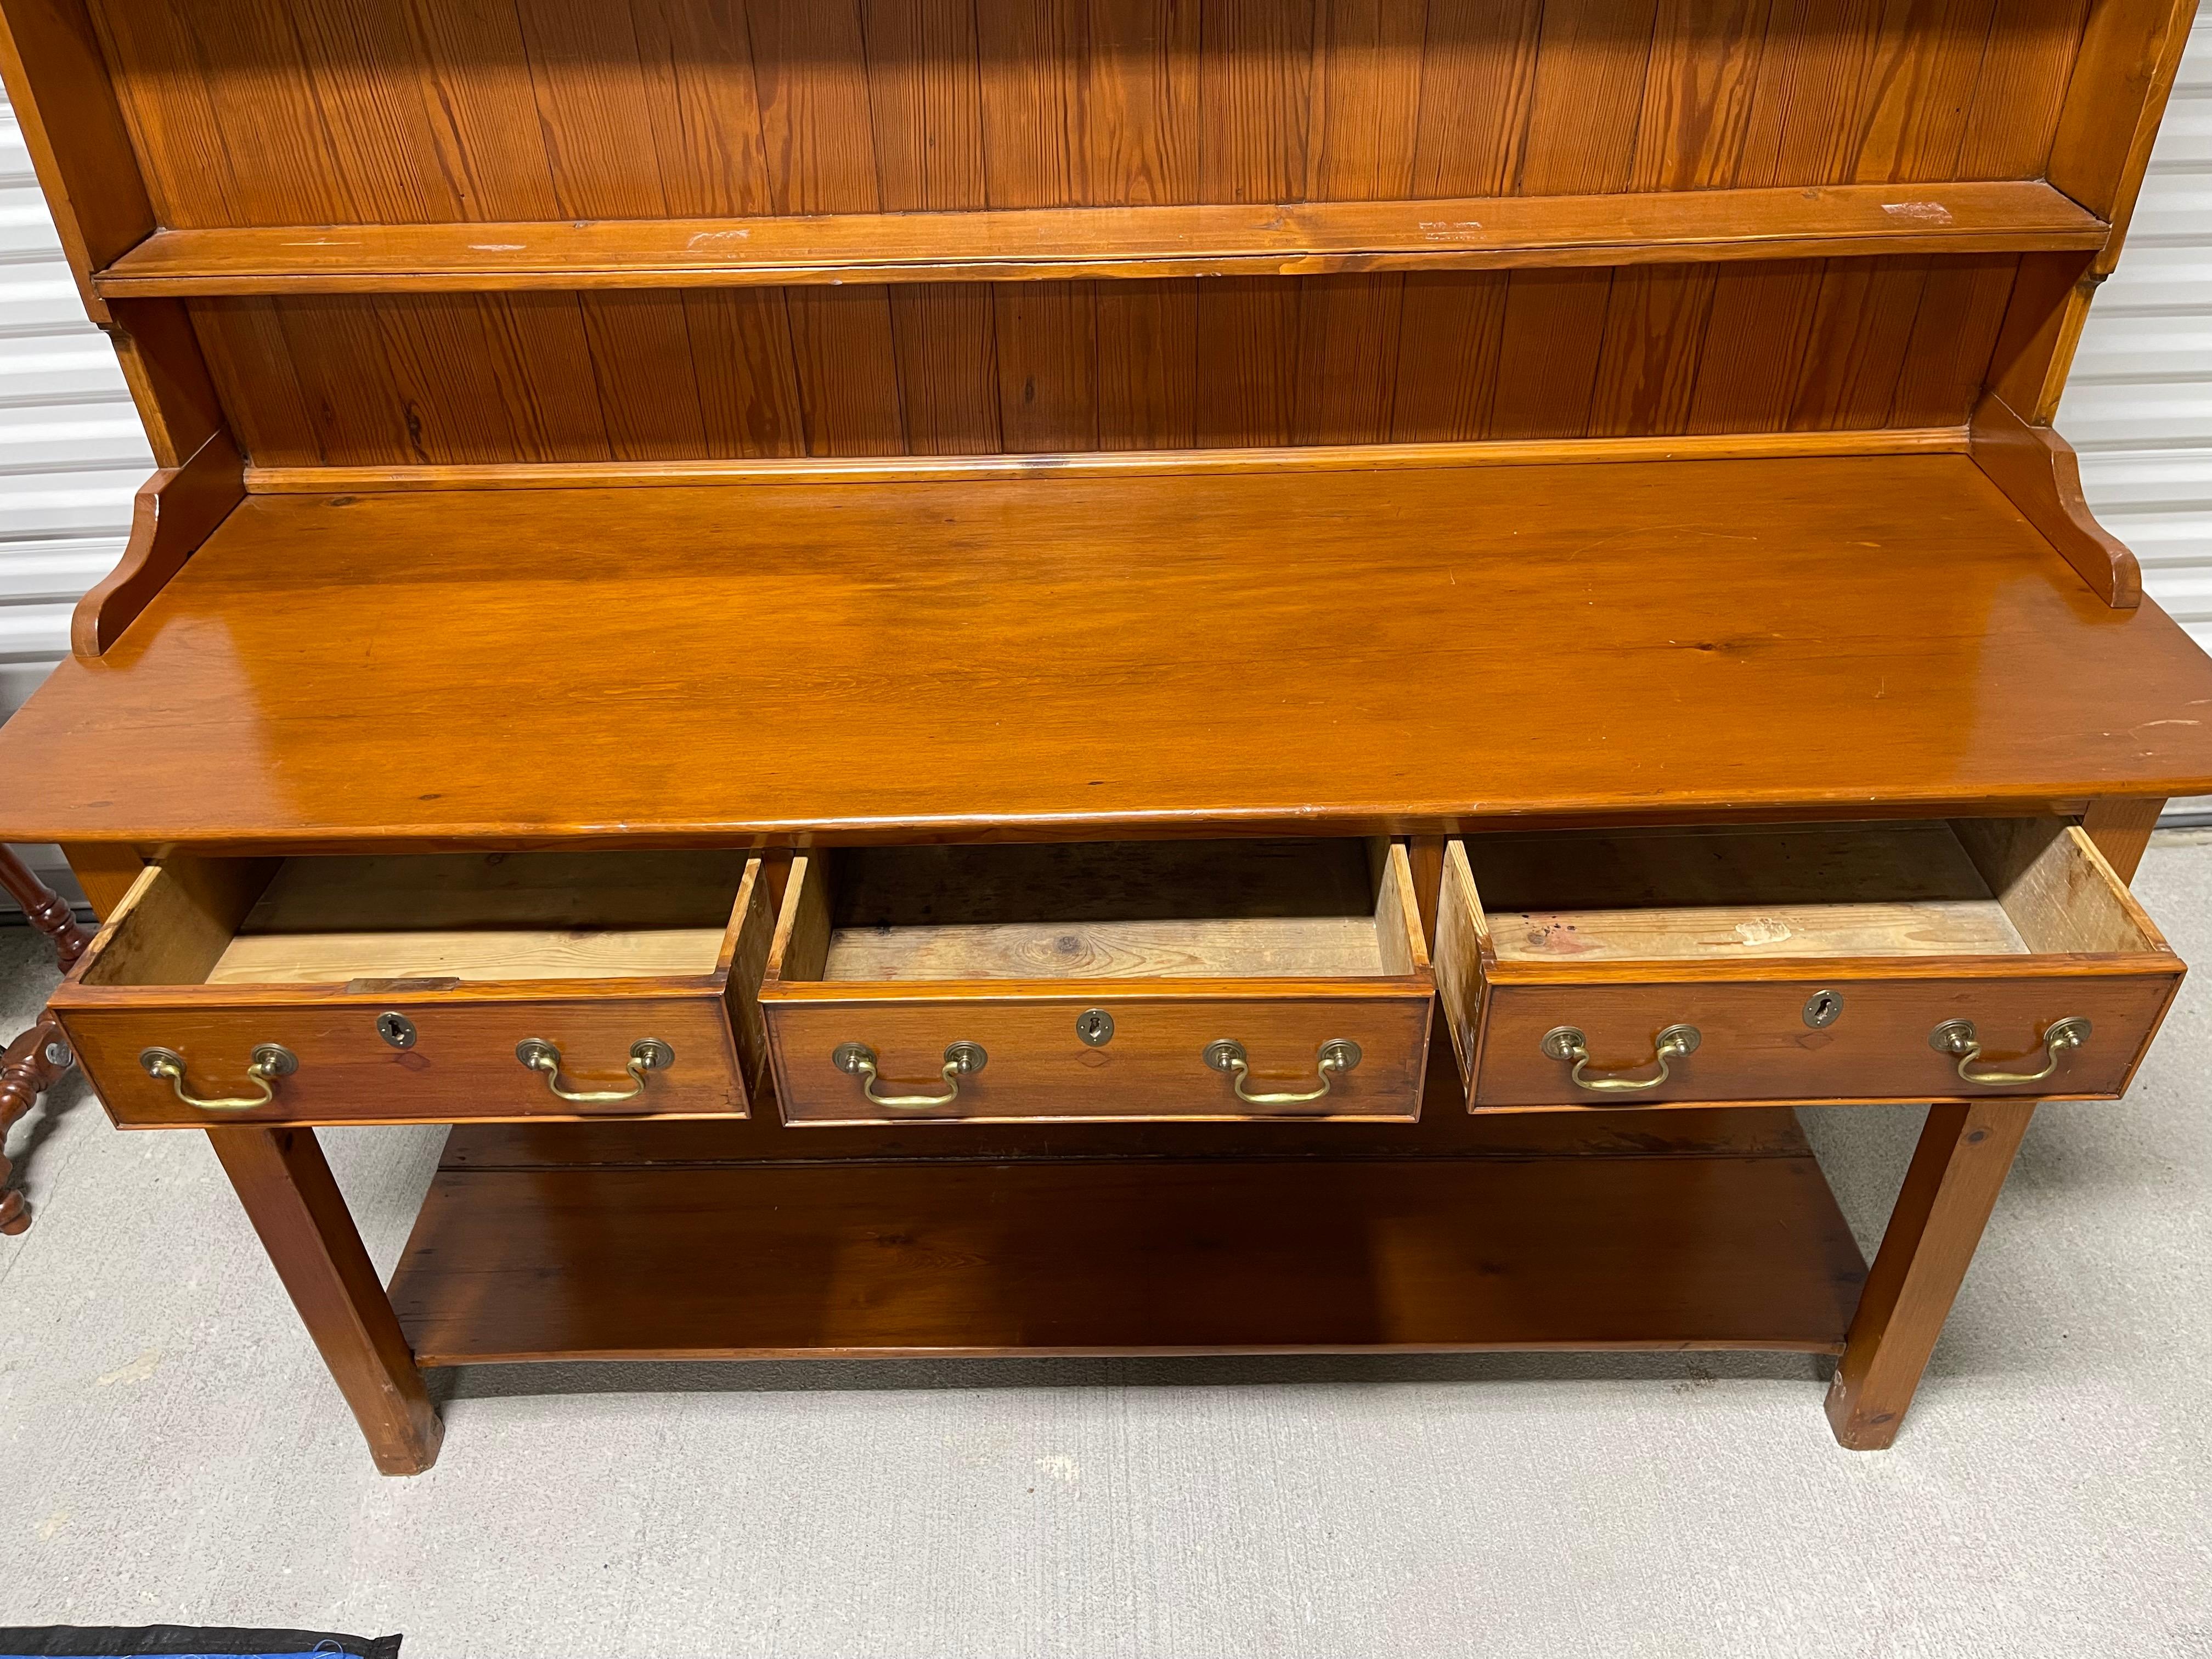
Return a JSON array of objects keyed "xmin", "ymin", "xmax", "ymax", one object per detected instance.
[{"xmin": 0, "ymin": 456, "xmax": 2212, "ymax": 849}]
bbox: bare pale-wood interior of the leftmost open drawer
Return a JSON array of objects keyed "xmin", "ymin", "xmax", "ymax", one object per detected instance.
[{"xmin": 82, "ymin": 851, "xmax": 748, "ymax": 989}]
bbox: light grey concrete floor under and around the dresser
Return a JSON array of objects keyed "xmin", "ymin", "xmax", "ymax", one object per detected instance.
[{"xmin": 0, "ymin": 836, "xmax": 2212, "ymax": 1659}]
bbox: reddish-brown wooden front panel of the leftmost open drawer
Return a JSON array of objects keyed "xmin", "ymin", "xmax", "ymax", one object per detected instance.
[{"xmin": 60, "ymin": 991, "xmax": 746, "ymax": 1128}]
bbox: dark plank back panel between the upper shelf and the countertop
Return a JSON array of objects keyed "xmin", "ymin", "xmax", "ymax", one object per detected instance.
[{"xmin": 184, "ymin": 255, "xmax": 2019, "ymax": 467}]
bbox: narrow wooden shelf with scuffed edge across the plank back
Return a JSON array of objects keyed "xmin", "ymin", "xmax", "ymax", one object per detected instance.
[{"xmin": 95, "ymin": 179, "xmax": 2108, "ymax": 298}]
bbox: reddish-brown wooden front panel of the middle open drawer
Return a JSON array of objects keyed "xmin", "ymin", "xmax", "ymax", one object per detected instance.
[{"xmin": 763, "ymin": 986, "xmax": 1434, "ymax": 1124}]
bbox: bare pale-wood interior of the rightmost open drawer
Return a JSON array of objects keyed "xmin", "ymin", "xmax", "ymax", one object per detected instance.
[{"xmin": 1466, "ymin": 819, "xmax": 2165, "ymax": 962}]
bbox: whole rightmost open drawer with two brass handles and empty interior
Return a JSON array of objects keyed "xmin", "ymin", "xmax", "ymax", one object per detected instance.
[{"xmin": 1436, "ymin": 819, "xmax": 2183, "ymax": 1108}]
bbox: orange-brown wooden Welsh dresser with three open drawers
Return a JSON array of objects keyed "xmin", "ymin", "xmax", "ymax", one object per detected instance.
[{"xmin": 0, "ymin": 0, "xmax": 2212, "ymax": 1473}]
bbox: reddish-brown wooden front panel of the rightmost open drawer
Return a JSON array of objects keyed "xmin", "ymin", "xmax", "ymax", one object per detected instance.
[{"xmin": 1453, "ymin": 973, "xmax": 2181, "ymax": 1108}]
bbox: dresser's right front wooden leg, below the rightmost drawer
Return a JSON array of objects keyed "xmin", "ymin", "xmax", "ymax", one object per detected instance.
[{"xmin": 1827, "ymin": 1099, "xmax": 2035, "ymax": 1451}]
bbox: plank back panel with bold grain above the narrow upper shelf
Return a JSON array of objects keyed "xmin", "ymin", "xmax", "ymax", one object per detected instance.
[{"xmin": 78, "ymin": 0, "xmax": 2086, "ymax": 228}]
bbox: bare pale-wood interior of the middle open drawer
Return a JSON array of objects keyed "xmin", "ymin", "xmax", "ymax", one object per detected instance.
[{"xmin": 778, "ymin": 840, "xmax": 1425, "ymax": 984}]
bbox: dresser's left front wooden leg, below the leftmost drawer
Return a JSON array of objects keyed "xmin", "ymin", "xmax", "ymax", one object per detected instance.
[{"xmin": 208, "ymin": 1126, "xmax": 444, "ymax": 1475}]
